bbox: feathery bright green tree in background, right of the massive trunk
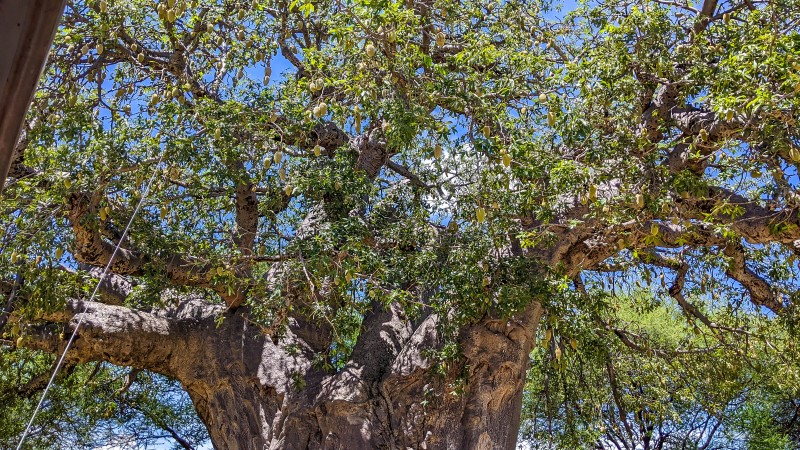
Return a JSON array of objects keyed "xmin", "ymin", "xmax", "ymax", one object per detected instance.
[{"xmin": 520, "ymin": 286, "xmax": 799, "ymax": 450}]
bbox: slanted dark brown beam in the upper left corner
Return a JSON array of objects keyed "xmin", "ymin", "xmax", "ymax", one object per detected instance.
[{"xmin": 0, "ymin": 0, "xmax": 66, "ymax": 194}]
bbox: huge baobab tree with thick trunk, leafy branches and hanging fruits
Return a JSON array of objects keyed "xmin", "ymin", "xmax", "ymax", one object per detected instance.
[{"xmin": 0, "ymin": 0, "xmax": 800, "ymax": 449}]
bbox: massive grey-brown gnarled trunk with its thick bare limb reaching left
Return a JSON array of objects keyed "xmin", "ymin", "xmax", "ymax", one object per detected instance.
[{"xmin": 34, "ymin": 302, "xmax": 542, "ymax": 450}]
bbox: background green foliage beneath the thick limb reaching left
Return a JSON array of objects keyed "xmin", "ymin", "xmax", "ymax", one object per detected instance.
[{"xmin": 0, "ymin": 356, "xmax": 208, "ymax": 450}]
